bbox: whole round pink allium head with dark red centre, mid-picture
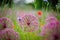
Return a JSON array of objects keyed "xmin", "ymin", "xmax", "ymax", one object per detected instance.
[{"xmin": 19, "ymin": 14, "xmax": 38, "ymax": 32}]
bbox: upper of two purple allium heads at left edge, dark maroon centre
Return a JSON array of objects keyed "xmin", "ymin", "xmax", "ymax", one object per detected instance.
[{"xmin": 0, "ymin": 17, "xmax": 14, "ymax": 30}]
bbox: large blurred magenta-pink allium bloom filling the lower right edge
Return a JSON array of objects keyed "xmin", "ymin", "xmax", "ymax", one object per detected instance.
[{"xmin": 40, "ymin": 17, "xmax": 60, "ymax": 40}]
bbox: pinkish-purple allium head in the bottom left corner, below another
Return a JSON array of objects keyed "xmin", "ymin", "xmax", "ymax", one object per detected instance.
[{"xmin": 0, "ymin": 28, "xmax": 20, "ymax": 40}]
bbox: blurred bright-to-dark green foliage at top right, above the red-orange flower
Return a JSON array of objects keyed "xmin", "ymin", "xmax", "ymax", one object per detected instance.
[{"xmin": 34, "ymin": 0, "xmax": 58, "ymax": 10}]
